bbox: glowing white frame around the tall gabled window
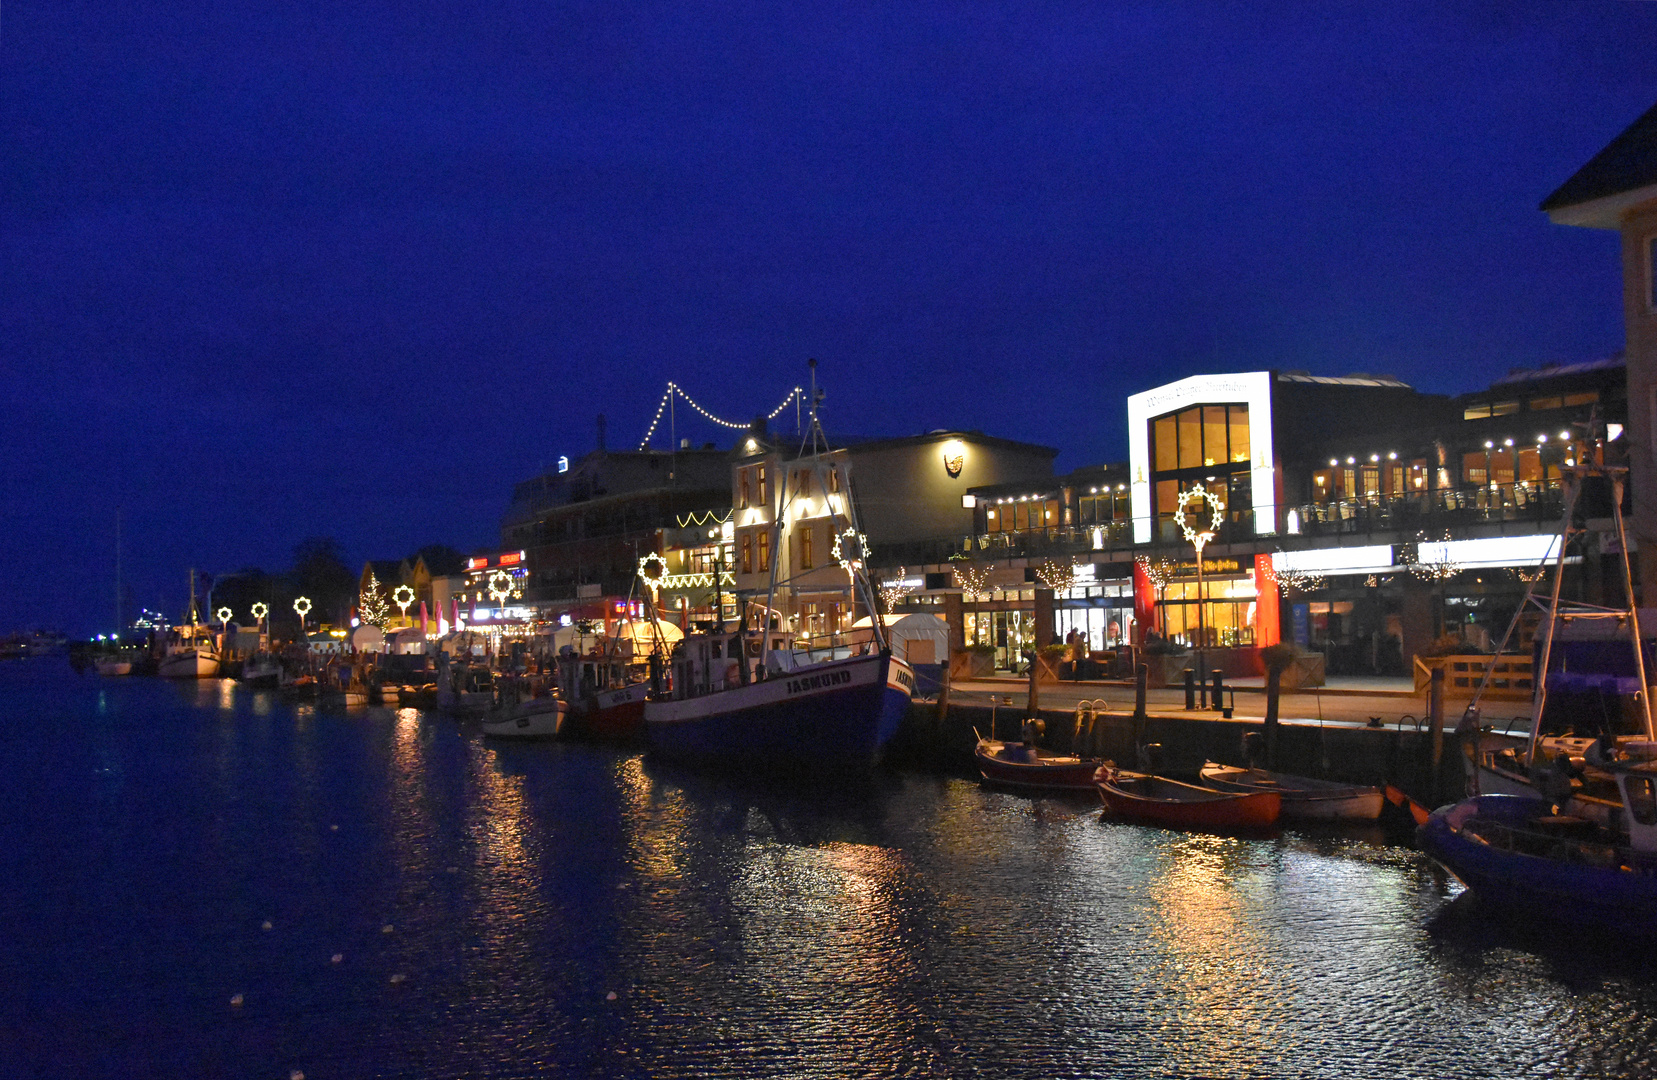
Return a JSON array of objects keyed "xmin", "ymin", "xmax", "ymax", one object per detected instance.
[{"xmin": 1128, "ymin": 371, "xmax": 1278, "ymax": 543}]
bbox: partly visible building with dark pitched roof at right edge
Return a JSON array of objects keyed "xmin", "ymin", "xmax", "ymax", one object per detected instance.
[{"xmin": 1541, "ymin": 96, "xmax": 1657, "ymax": 603}]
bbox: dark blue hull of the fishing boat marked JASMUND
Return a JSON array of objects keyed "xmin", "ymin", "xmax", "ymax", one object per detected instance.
[{"xmin": 645, "ymin": 654, "xmax": 915, "ymax": 767}]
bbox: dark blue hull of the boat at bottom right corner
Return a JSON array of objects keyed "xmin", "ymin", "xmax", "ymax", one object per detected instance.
[{"xmin": 1417, "ymin": 795, "xmax": 1657, "ymax": 936}]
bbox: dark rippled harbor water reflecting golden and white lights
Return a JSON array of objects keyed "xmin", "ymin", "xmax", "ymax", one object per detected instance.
[{"xmin": 0, "ymin": 659, "xmax": 1657, "ymax": 1080}]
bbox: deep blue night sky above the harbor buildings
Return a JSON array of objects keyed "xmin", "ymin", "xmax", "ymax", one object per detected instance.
[{"xmin": 0, "ymin": 0, "xmax": 1657, "ymax": 633}]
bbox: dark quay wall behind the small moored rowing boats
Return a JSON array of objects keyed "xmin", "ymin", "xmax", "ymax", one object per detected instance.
[{"xmin": 888, "ymin": 702, "xmax": 1466, "ymax": 807}]
